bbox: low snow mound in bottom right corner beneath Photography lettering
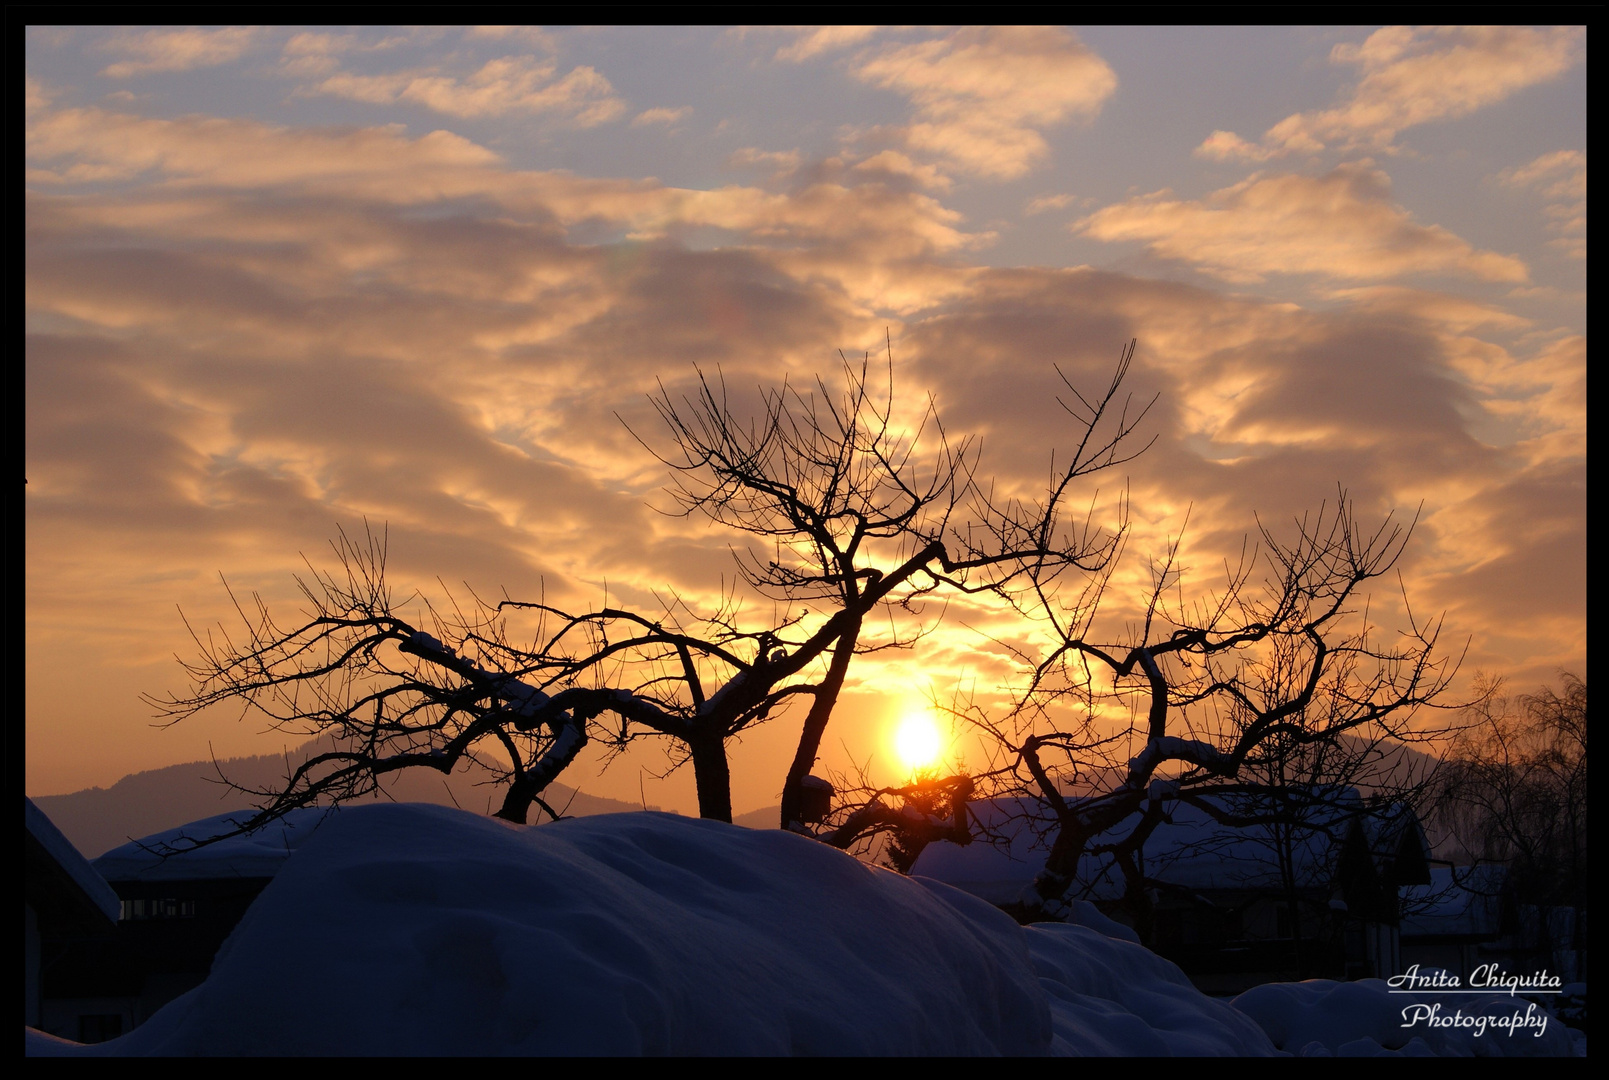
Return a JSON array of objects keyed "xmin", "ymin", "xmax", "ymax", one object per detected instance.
[{"xmin": 1234, "ymin": 979, "xmax": 1585, "ymax": 1057}]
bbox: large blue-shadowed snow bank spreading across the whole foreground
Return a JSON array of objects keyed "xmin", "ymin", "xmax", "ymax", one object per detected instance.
[{"xmin": 27, "ymin": 805, "xmax": 1572, "ymax": 1056}]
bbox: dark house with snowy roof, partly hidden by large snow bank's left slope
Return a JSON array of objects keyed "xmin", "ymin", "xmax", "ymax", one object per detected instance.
[{"xmin": 37, "ymin": 808, "xmax": 330, "ymax": 1041}]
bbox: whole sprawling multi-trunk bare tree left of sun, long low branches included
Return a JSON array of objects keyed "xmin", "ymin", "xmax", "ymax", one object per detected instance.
[{"xmin": 151, "ymin": 343, "xmax": 1149, "ymax": 829}]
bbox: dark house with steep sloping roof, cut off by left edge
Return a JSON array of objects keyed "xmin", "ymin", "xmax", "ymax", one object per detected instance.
[{"xmin": 23, "ymin": 797, "xmax": 122, "ymax": 1038}]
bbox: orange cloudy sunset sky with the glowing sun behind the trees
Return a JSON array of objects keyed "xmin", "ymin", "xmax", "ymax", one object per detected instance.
[{"xmin": 26, "ymin": 27, "xmax": 1586, "ymax": 813}]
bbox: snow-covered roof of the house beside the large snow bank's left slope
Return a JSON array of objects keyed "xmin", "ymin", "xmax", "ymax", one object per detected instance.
[{"xmin": 93, "ymin": 806, "xmax": 338, "ymax": 882}]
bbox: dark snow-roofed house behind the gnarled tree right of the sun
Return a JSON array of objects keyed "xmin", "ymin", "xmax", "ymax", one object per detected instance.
[{"xmin": 911, "ymin": 789, "xmax": 1429, "ymax": 993}]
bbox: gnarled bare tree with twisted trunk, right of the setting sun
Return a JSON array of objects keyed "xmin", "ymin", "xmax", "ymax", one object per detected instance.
[{"xmin": 964, "ymin": 491, "xmax": 1458, "ymax": 922}]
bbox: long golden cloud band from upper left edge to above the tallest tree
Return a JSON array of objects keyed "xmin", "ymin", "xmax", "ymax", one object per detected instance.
[{"xmin": 27, "ymin": 108, "xmax": 988, "ymax": 311}]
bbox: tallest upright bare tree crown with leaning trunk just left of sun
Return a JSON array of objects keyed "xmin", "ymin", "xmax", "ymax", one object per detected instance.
[{"xmin": 633, "ymin": 343, "xmax": 1149, "ymax": 827}]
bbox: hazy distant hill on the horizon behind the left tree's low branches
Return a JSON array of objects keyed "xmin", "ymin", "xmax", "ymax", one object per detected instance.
[{"xmin": 34, "ymin": 740, "xmax": 659, "ymax": 858}]
